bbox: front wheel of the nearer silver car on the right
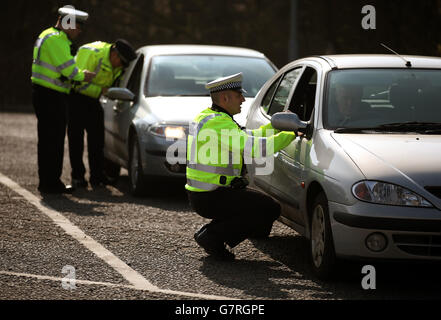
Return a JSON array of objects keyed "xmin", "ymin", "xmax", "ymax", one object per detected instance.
[{"xmin": 310, "ymin": 192, "xmax": 336, "ymax": 280}]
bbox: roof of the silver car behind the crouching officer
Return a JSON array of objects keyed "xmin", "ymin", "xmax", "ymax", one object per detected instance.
[{"xmin": 138, "ymin": 44, "xmax": 265, "ymax": 58}]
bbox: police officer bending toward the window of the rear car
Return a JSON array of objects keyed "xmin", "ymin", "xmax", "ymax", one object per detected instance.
[{"xmin": 68, "ymin": 40, "xmax": 136, "ymax": 187}]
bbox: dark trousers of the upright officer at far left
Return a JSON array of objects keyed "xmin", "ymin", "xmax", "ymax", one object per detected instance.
[{"xmin": 32, "ymin": 84, "xmax": 68, "ymax": 190}]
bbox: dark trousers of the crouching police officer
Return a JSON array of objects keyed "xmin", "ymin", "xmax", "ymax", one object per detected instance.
[{"xmin": 187, "ymin": 188, "xmax": 280, "ymax": 248}]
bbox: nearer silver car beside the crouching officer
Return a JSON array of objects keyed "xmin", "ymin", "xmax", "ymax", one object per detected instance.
[{"xmin": 247, "ymin": 55, "xmax": 441, "ymax": 278}]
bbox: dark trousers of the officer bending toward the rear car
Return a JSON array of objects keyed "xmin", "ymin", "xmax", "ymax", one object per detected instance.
[{"xmin": 68, "ymin": 93, "xmax": 104, "ymax": 182}]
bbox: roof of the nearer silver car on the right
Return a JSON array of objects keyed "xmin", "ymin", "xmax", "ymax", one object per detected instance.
[{"xmin": 301, "ymin": 54, "xmax": 441, "ymax": 69}]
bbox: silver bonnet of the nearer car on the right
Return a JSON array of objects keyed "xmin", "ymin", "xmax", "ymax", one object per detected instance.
[{"xmin": 331, "ymin": 133, "xmax": 441, "ymax": 189}]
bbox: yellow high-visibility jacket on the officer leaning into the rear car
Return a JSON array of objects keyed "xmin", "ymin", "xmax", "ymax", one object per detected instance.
[{"xmin": 74, "ymin": 41, "xmax": 122, "ymax": 99}]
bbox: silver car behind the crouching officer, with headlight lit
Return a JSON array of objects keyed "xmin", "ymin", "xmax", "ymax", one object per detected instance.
[{"xmin": 101, "ymin": 45, "xmax": 277, "ymax": 195}]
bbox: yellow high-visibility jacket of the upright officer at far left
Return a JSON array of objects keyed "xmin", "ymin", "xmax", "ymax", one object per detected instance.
[{"xmin": 31, "ymin": 28, "xmax": 84, "ymax": 93}]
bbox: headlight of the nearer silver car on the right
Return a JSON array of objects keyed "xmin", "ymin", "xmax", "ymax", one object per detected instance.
[{"xmin": 352, "ymin": 181, "xmax": 432, "ymax": 207}]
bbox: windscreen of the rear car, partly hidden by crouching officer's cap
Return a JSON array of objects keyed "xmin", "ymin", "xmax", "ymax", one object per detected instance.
[{"xmin": 145, "ymin": 55, "xmax": 276, "ymax": 97}]
